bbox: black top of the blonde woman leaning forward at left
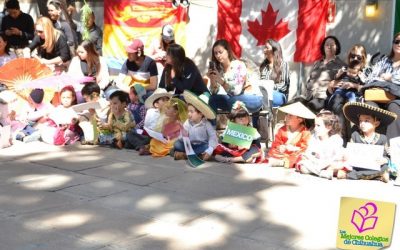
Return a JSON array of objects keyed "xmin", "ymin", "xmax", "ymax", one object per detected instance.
[{"xmin": 28, "ymin": 34, "xmax": 71, "ymax": 62}]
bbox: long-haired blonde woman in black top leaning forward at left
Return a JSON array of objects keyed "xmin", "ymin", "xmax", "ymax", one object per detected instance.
[{"xmin": 24, "ymin": 17, "xmax": 71, "ymax": 72}]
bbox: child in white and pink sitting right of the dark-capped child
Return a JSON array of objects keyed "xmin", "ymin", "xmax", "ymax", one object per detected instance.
[{"xmin": 41, "ymin": 86, "xmax": 82, "ymax": 145}]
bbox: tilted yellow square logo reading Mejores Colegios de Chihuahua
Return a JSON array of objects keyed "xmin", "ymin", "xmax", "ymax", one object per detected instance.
[{"xmin": 336, "ymin": 197, "xmax": 396, "ymax": 249}]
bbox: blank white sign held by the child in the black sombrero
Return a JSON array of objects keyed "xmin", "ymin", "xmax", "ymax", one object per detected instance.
[{"xmin": 346, "ymin": 142, "xmax": 384, "ymax": 170}]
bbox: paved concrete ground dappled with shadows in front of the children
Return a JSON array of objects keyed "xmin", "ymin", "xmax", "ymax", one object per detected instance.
[{"xmin": 0, "ymin": 142, "xmax": 400, "ymax": 250}]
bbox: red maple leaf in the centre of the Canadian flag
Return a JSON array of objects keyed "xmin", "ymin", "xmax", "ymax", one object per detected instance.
[{"xmin": 247, "ymin": 3, "xmax": 290, "ymax": 46}]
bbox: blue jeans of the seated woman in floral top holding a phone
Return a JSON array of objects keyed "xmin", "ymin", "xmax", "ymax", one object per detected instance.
[{"xmin": 208, "ymin": 94, "xmax": 262, "ymax": 113}]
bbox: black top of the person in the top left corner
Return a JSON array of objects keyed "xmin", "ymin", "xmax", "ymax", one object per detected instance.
[{"xmin": 1, "ymin": 12, "xmax": 35, "ymax": 48}]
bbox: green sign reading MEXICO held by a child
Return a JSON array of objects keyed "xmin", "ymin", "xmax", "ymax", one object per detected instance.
[{"xmin": 222, "ymin": 122, "xmax": 260, "ymax": 149}]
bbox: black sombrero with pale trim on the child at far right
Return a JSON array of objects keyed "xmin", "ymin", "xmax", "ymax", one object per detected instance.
[{"xmin": 343, "ymin": 102, "xmax": 397, "ymax": 127}]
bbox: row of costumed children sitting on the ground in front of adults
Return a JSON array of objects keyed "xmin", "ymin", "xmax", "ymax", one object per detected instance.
[{"xmin": 0, "ymin": 83, "xmax": 396, "ymax": 182}]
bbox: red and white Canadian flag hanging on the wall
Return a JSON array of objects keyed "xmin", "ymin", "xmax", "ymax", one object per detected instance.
[{"xmin": 217, "ymin": 0, "xmax": 329, "ymax": 63}]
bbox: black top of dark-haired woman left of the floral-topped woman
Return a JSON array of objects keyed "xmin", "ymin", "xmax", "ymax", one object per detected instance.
[{"xmin": 159, "ymin": 58, "xmax": 209, "ymax": 95}]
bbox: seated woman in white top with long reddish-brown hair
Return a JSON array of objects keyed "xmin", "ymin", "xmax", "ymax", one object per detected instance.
[{"xmin": 68, "ymin": 41, "xmax": 110, "ymax": 90}]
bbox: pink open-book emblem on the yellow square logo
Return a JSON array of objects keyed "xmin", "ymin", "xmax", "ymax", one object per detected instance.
[{"xmin": 351, "ymin": 202, "xmax": 378, "ymax": 233}]
